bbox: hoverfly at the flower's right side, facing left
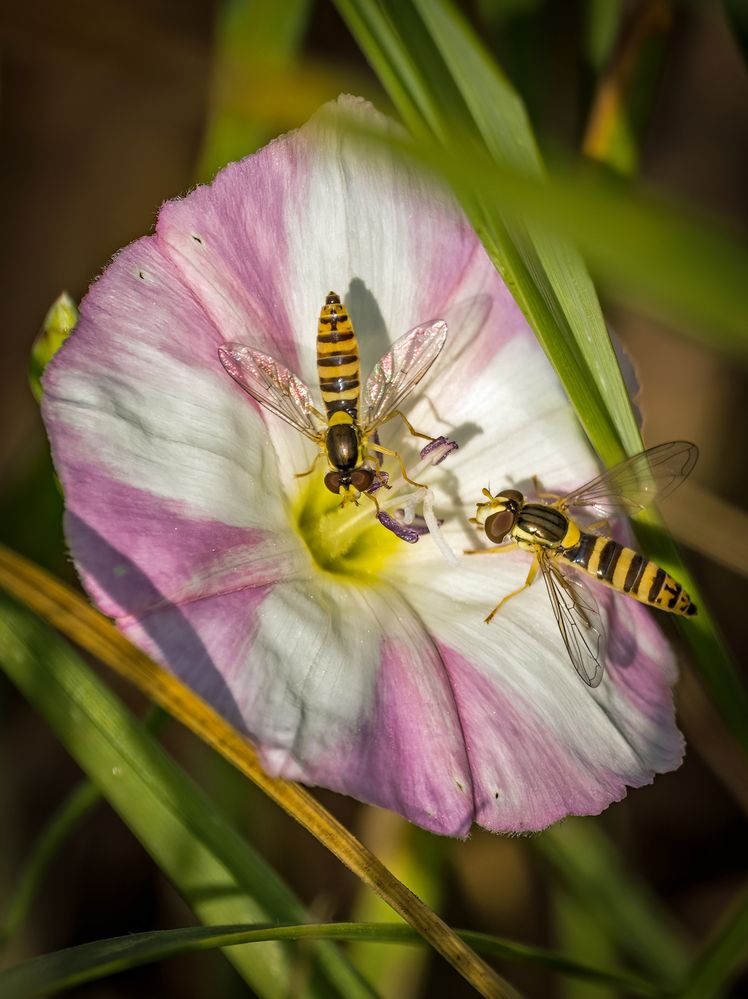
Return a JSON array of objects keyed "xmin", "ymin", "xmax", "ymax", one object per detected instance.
[{"xmin": 467, "ymin": 441, "xmax": 698, "ymax": 687}]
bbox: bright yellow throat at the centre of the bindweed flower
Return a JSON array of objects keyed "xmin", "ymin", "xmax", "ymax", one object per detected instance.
[{"xmin": 291, "ymin": 475, "xmax": 404, "ymax": 583}]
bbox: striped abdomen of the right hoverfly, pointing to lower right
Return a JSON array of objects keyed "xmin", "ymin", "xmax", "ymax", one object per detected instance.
[{"xmin": 559, "ymin": 532, "xmax": 696, "ymax": 617}]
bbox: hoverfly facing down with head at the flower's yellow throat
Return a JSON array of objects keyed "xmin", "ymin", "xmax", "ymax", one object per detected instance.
[{"xmin": 218, "ymin": 291, "xmax": 447, "ymax": 510}]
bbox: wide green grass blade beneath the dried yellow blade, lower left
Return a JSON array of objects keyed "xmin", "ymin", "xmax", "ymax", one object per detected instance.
[{"xmin": 0, "ymin": 596, "xmax": 371, "ymax": 997}]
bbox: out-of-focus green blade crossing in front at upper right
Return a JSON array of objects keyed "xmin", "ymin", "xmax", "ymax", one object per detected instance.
[{"xmin": 452, "ymin": 146, "xmax": 748, "ymax": 358}]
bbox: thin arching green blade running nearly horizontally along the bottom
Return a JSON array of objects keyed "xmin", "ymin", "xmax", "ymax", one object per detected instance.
[{"xmin": 0, "ymin": 923, "xmax": 657, "ymax": 999}]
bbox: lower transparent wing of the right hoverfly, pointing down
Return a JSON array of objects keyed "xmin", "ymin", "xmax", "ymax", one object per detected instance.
[{"xmin": 538, "ymin": 552, "xmax": 606, "ymax": 687}]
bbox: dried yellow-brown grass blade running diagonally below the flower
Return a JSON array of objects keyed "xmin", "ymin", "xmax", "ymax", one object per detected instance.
[{"xmin": 0, "ymin": 545, "xmax": 518, "ymax": 999}]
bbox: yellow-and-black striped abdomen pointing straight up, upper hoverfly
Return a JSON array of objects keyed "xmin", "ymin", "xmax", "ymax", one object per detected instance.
[{"xmin": 317, "ymin": 291, "xmax": 360, "ymax": 420}]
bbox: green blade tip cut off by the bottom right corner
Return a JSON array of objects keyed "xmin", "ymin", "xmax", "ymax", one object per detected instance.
[{"xmin": 678, "ymin": 889, "xmax": 748, "ymax": 999}]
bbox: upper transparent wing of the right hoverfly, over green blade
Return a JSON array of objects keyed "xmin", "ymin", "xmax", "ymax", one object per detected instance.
[{"xmin": 562, "ymin": 441, "xmax": 699, "ymax": 517}]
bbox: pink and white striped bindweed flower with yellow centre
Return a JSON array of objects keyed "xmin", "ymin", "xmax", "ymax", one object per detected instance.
[{"xmin": 44, "ymin": 98, "xmax": 682, "ymax": 836}]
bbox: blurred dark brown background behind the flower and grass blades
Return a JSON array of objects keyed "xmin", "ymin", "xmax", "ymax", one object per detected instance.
[{"xmin": 0, "ymin": 0, "xmax": 748, "ymax": 997}]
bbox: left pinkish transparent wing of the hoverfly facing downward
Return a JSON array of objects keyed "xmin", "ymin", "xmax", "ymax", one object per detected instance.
[{"xmin": 218, "ymin": 343, "xmax": 319, "ymax": 441}]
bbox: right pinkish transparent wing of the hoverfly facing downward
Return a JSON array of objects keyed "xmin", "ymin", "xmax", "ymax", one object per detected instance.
[{"xmin": 361, "ymin": 319, "xmax": 447, "ymax": 433}]
